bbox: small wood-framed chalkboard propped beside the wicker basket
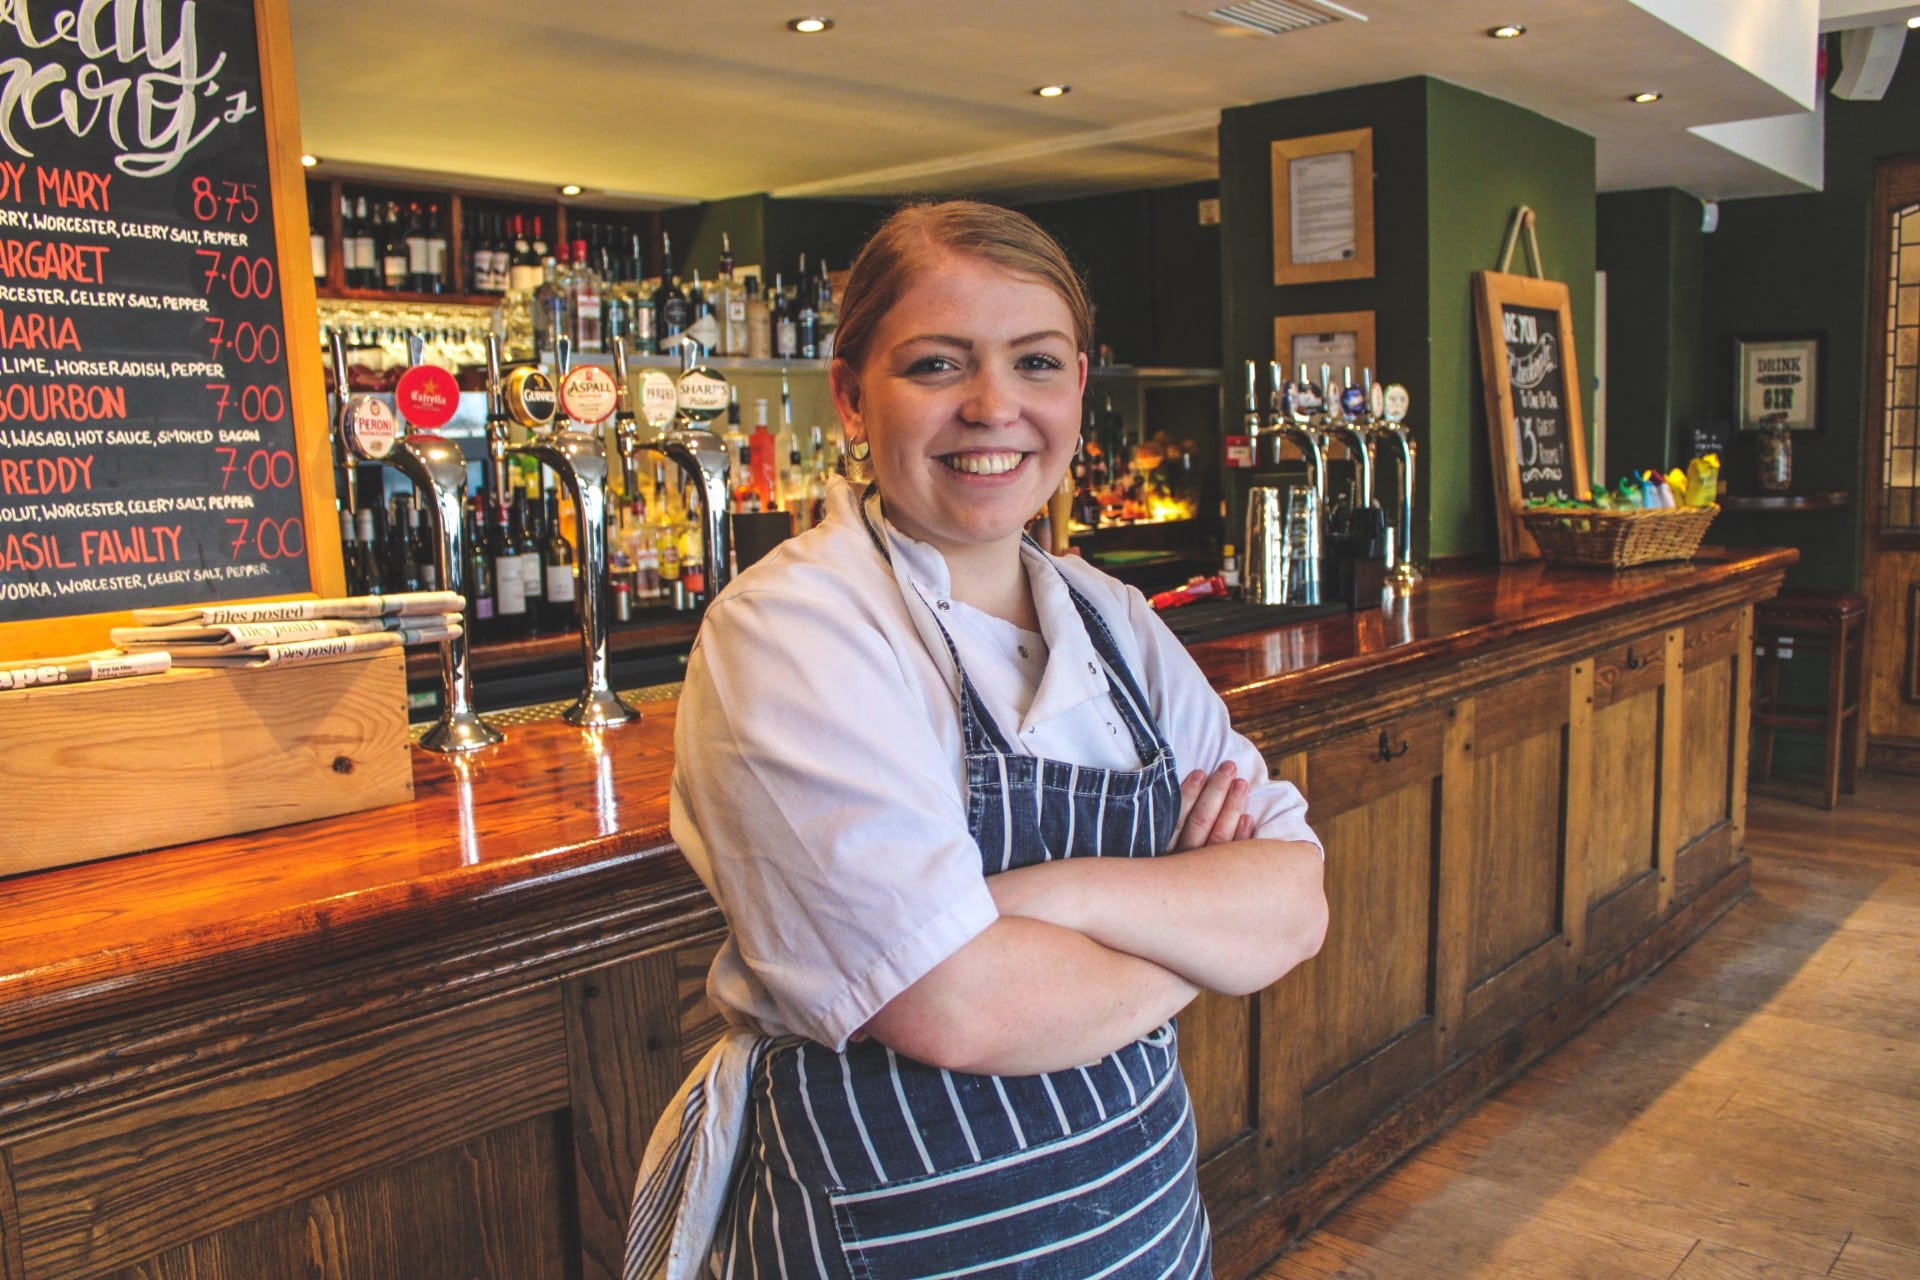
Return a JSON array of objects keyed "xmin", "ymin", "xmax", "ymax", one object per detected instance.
[{"xmin": 1473, "ymin": 271, "xmax": 1588, "ymax": 560}]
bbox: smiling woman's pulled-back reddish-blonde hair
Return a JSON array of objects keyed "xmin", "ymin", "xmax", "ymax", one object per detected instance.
[{"xmin": 833, "ymin": 200, "xmax": 1092, "ymax": 368}]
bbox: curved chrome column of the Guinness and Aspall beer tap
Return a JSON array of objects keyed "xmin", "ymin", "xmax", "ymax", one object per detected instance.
[{"xmin": 518, "ymin": 338, "xmax": 639, "ymax": 729}]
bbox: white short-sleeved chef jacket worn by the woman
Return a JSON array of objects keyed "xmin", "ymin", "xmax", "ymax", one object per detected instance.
[{"xmin": 670, "ymin": 478, "xmax": 1319, "ymax": 1048}]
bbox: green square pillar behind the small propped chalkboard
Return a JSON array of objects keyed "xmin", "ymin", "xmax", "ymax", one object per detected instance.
[{"xmin": 1221, "ymin": 77, "xmax": 1596, "ymax": 558}]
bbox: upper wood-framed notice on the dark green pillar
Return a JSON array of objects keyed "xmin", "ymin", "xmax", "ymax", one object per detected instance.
[{"xmin": 1273, "ymin": 129, "xmax": 1373, "ymax": 284}]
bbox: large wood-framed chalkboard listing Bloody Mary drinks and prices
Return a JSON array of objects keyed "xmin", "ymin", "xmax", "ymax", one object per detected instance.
[{"xmin": 0, "ymin": 0, "xmax": 344, "ymax": 658}]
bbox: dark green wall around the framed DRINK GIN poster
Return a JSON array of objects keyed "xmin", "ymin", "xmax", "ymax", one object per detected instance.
[{"xmin": 1703, "ymin": 40, "xmax": 1920, "ymax": 589}]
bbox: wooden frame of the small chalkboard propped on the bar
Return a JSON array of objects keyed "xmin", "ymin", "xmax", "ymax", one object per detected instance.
[{"xmin": 1473, "ymin": 271, "xmax": 1590, "ymax": 562}]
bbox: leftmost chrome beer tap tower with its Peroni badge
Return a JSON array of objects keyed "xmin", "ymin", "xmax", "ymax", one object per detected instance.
[{"xmin": 330, "ymin": 330, "xmax": 501, "ymax": 754}]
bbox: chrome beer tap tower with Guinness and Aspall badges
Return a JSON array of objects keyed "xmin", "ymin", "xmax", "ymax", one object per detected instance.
[{"xmin": 486, "ymin": 334, "xmax": 639, "ymax": 729}]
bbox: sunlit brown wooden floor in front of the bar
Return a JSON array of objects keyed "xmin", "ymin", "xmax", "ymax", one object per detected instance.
[{"xmin": 1261, "ymin": 773, "xmax": 1920, "ymax": 1280}]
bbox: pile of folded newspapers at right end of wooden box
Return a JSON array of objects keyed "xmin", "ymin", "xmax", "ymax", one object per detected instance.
[{"xmin": 111, "ymin": 591, "xmax": 467, "ymax": 666}]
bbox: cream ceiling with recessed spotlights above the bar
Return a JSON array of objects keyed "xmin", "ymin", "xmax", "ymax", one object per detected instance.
[{"xmin": 290, "ymin": 0, "xmax": 1887, "ymax": 203}]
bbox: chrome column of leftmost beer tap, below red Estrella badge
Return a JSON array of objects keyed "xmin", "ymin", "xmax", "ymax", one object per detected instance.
[{"xmin": 386, "ymin": 334, "xmax": 503, "ymax": 754}]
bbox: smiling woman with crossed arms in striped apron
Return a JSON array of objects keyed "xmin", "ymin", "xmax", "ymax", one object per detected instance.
[{"xmin": 628, "ymin": 201, "xmax": 1327, "ymax": 1280}]
